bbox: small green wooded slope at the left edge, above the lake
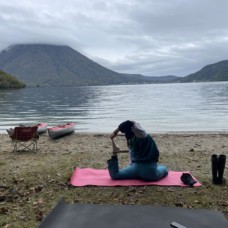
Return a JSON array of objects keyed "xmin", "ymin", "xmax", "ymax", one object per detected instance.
[{"xmin": 0, "ymin": 70, "xmax": 25, "ymax": 89}]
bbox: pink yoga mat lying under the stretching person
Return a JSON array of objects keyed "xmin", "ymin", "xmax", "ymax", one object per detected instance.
[{"xmin": 70, "ymin": 168, "xmax": 201, "ymax": 187}]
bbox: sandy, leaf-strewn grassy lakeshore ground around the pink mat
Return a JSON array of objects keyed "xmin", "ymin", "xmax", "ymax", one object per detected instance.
[{"xmin": 0, "ymin": 132, "xmax": 228, "ymax": 227}]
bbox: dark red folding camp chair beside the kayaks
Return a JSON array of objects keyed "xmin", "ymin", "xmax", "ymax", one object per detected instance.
[{"xmin": 9, "ymin": 126, "xmax": 39, "ymax": 152}]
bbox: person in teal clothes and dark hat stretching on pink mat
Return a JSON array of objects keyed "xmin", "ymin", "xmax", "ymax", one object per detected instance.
[{"xmin": 107, "ymin": 120, "xmax": 168, "ymax": 181}]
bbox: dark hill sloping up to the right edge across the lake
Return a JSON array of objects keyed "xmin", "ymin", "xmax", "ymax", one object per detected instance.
[{"xmin": 176, "ymin": 60, "xmax": 228, "ymax": 82}]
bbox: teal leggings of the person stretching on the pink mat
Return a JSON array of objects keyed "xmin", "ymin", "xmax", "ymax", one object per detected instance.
[{"xmin": 107, "ymin": 157, "xmax": 168, "ymax": 181}]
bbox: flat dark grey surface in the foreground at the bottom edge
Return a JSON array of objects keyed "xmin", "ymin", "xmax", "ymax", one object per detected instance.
[{"xmin": 39, "ymin": 200, "xmax": 228, "ymax": 228}]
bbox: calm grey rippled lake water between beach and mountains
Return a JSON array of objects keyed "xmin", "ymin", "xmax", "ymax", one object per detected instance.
[{"xmin": 0, "ymin": 82, "xmax": 228, "ymax": 133}]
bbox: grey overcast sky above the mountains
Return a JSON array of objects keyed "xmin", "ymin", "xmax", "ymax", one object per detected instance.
[{"xmin": 0, "ymin": 0, "xmax": 228, "ymax": 76}]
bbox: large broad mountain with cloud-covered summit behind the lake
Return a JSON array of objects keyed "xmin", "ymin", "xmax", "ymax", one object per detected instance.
[{"xmin": 0, "ymin": 44, "xmax": 177, "ymax": 86}]
